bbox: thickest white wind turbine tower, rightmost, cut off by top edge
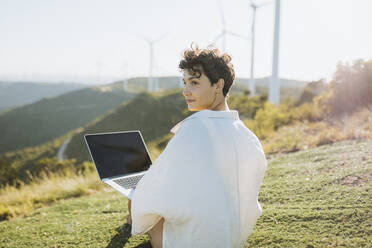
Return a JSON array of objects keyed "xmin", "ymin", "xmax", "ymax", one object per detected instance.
[{"xmin": 269, "ymin": 0, "xmax": 280, "ymax": 105}]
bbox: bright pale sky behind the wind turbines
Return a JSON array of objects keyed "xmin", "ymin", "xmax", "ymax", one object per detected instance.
[{"xmin": 0, "ymin": 0, "xmax": 372, "ymax": 83}]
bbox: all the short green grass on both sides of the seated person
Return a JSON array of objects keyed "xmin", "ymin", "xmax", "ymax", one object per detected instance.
[{"xmin": 0, "ymin": 140, "xmax": 372, "ymax": 248}]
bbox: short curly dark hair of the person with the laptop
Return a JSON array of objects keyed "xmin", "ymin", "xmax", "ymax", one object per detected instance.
[{"xmin": 178, "ymin": 44, "xmax": 235, "ymax": 97}]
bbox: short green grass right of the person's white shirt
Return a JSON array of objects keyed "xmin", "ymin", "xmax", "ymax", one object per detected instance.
[{"xmin": 247, "ymin": 140, "xmax": 372, "ymax": 247}]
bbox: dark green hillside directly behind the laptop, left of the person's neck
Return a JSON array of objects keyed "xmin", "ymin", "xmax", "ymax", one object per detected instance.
[{"xmin": 64, "ymin": 90, "xmax": 188, "ymax": 162}]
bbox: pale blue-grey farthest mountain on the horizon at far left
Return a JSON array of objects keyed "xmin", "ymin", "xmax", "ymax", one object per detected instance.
[{"xmin": 0, "ymin": 81, "xmax": 87, "ymax": 112}]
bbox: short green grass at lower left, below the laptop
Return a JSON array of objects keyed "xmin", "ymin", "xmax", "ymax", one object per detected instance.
[{"xmin": 0, "ymin": 192, "xmax": 148, "ymax": 247}]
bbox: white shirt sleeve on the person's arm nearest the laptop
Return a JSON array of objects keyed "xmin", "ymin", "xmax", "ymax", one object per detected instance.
[{"xmin": 132, "ymin": 120, "xmax": 217, "ymax": 234}]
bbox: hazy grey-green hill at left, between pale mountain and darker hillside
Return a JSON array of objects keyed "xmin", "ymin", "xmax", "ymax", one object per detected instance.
[{"xmin": 0, "ymin": 85, "xmax": 134, "ymax": 154}]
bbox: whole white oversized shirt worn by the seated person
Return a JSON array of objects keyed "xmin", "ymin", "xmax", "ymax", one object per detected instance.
[{"xmin": 132, "ymin": 110, "xmax": 267, "ymax": 248}]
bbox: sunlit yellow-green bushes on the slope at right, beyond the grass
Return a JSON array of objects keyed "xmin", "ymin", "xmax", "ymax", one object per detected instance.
[{"xmin": 245, "ymin": 60, "xmax": 372, "ymax": 153}]
